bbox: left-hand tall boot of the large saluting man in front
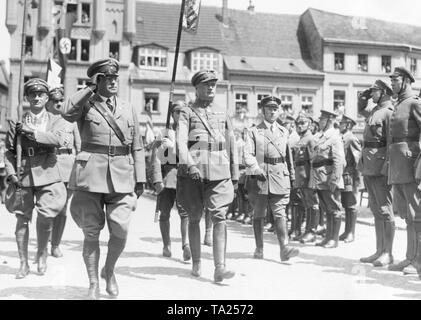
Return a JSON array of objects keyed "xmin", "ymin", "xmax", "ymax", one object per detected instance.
[{"xmin": 82, "ymin": 239, "xmax": 100, "ymax": 300}]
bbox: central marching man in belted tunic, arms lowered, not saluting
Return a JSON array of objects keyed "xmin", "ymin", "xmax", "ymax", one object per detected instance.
[{"xmin": 176, "ymin": 70, "xmax": 238, "ymax": 282}]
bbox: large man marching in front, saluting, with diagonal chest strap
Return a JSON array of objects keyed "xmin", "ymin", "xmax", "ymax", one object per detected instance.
[{"xmin": 62, "ymin": 59, "xmax": 146, "ymax": 299}]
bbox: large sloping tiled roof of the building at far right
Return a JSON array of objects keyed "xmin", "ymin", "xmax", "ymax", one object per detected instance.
[{"xmin": 304, "ymin": 8, "xmax": 421, "ymax": 47}]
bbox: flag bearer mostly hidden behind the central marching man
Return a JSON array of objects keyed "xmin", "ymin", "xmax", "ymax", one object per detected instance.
[{"xmin": 151, "ymin": 101, "xmax": 191, "ymax": 261}]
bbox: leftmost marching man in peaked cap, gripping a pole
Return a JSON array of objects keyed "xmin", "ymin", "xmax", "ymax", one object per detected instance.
[{"xmin": 5, "ymin": 78, "xmax": 67, "ymax": 279}]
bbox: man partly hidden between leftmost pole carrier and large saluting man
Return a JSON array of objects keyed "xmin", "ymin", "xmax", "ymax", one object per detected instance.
[{"xmin": 47, "ymin": 87, "xmax": 80, "ymax": 258}]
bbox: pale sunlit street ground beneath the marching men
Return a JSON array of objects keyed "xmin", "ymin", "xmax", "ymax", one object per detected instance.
[{"xmin": 0, "ymin": 194, "xmax": 421, "ymax": 301}]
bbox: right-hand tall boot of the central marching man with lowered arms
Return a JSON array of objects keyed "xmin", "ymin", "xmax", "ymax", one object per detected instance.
[{"xmin": 213, "ymin": 221, "xmax": 235, "ymax": 282}]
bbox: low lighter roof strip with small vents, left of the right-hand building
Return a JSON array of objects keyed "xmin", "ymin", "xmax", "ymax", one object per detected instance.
[{"xmin": 225, "ymin": 56, "xmax": 324, "ymax": 77}]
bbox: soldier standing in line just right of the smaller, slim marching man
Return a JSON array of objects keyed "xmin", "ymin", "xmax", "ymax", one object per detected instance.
[{"xmin": 292, "ymin": 113, "xmax": 319, "ymax": 243}]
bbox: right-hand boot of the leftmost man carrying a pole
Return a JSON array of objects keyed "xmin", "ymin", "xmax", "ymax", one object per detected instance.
[{"xmin": 36, "ymin": 214, "xmax": 53, "ymax": 275}]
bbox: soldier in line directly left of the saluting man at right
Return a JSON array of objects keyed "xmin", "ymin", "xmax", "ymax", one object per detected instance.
[{"xmin": 339, "ymin": 112, "xmax": 361, "ymax": 243}]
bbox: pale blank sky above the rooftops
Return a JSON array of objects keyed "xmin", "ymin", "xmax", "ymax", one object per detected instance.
[{"xmin": 0, "ymin": 0, "xmax": 421, "ymax": 72}]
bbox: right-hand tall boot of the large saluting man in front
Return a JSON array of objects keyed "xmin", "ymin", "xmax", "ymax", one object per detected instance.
[{"xmin": 101, "ymin": 234, "xmax": 126, "ymax": 297}]
